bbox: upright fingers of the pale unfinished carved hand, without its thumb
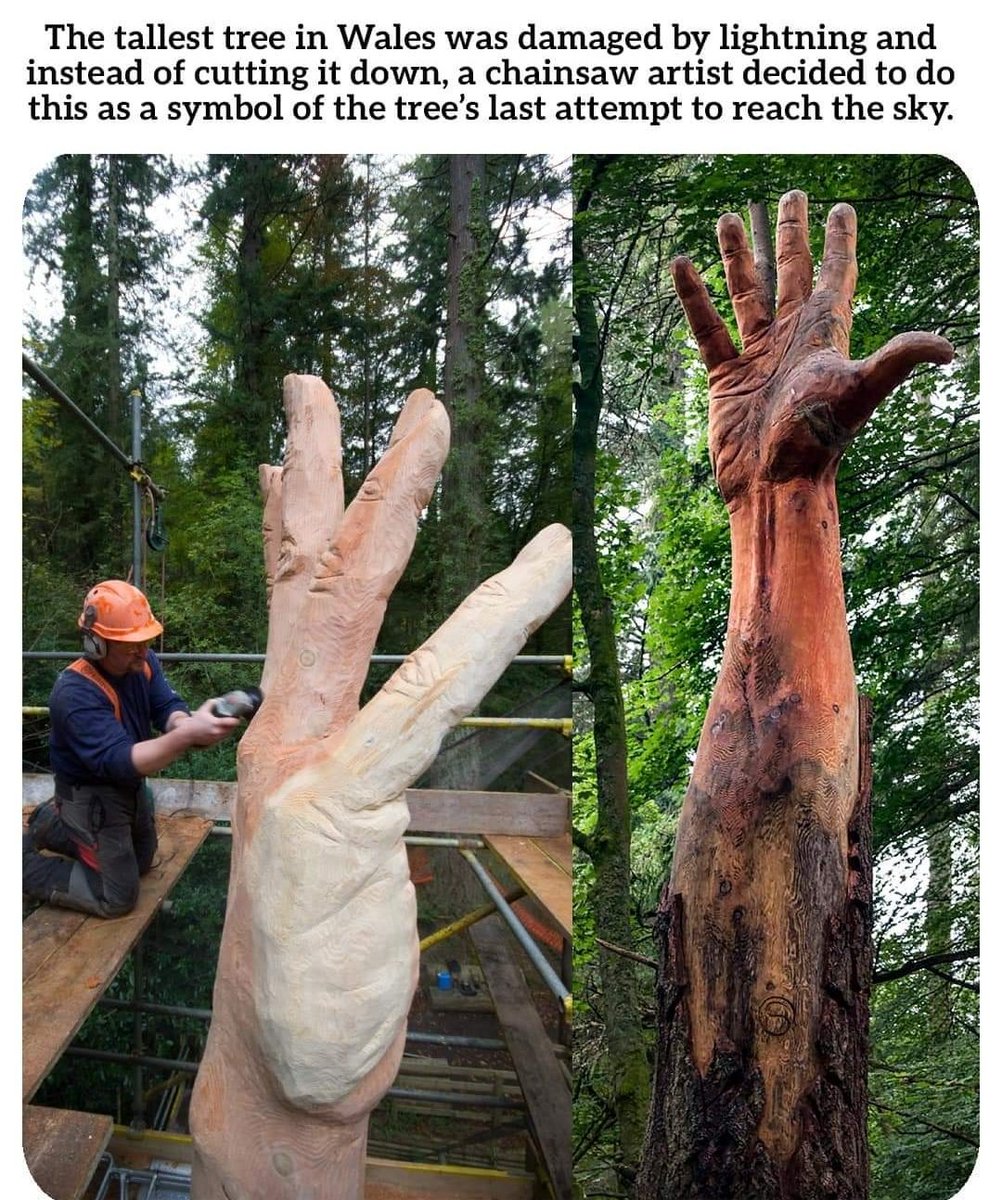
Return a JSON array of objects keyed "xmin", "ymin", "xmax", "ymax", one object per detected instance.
[{"xmin": 251, "ymin": 376, "xmax": 449, "ymax": 746}]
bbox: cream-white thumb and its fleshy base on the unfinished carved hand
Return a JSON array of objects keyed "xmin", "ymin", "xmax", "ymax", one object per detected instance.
[{"xmin": 244, "ymin": 528, "xmax": 571, "ymax": 1108}]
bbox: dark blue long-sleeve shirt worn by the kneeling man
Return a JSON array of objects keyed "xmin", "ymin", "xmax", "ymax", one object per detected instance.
[{"xmin": 49, "ymin": 650, "xmax": 188, "ymax": 786}]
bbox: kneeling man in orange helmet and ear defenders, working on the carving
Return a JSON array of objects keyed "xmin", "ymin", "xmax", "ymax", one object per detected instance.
[{"xmin": 22, "ymin": 580, "xmax": 240, "ymax": 917}]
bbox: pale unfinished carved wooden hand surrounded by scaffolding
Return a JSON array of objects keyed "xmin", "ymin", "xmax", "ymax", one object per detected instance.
[{"xmin": 191, "ymin": 376, "xmax": 571, "ymax": 1200}]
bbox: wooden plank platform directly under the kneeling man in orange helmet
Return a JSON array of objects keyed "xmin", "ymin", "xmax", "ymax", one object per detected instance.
[{"xmin": 22, "ymin": 815, "xmax": 212, "ymax": 1100}]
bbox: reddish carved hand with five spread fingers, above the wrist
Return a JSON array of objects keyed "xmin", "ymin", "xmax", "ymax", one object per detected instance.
[{"xmin": 672, "ymin": 192, "xmax": 953, "ymax": 504}]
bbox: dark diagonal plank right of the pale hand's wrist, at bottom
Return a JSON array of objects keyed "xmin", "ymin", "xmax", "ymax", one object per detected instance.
[{"xmin": 469, "ymin": 917, "xmax": 571, "ymax": 1200}]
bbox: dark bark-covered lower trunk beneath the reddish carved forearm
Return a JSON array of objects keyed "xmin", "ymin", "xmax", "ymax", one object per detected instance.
[{"xmin": 636, "ymin": 681, "xmax": 872, "ymax": 1200}]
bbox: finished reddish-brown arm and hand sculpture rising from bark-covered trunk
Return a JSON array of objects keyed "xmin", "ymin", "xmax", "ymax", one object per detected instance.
[{"xmin": 637, "ymin": 192, "xmax": 953, "ymax": 1200}]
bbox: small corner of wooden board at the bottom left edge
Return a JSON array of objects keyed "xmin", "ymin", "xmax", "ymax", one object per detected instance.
[{"xmin": 22, "ymin": 1104, "xmax": 112, "ymax": 1200}]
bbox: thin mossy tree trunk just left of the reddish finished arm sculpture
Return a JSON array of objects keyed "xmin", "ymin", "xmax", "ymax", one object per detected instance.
[{"xmin": 571, "ymin": 157, "xmax": 649, "ymax": 1175}]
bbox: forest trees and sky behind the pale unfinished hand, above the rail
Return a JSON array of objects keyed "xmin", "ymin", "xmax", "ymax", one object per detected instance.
[{"xmin": 23, "ymin": 155, "xmax": 570, "ymax": 703}]
